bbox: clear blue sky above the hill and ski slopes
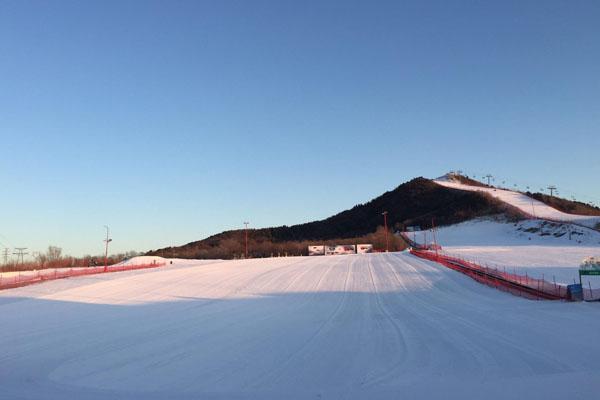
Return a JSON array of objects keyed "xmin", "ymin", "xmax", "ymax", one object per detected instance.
[{"xmin": 0, "ymin": 0, "xmax": 600, "ymax": 255}]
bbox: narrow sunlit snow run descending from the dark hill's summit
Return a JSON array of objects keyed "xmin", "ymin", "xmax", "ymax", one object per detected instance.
[{"xmin": 434, "ymin": 177, "xmax": 600, "ymax": 228}]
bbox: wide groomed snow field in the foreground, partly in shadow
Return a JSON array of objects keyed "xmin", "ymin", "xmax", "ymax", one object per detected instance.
[{"xmin": 0, "ymin": 253, "xmax": 600, "ymax": 399}]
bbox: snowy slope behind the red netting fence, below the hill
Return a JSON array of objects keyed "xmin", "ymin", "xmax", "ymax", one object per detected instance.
[{"xmin": 407, "ymin": 218, "xmax": 600, "ymax": 288}]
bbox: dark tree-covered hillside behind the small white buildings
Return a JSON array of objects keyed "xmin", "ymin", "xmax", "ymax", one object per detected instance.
[{"xmin": 148, "ymin": 178, "xmax": 518, "ymax": 258}]
